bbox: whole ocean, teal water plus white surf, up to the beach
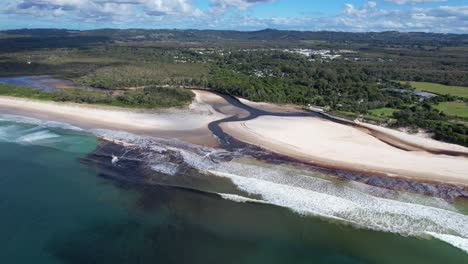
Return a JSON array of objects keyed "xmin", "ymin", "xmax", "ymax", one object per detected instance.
[{"xmin": 0, "ymin": 116, "xmax": 468, "ymax": 264}]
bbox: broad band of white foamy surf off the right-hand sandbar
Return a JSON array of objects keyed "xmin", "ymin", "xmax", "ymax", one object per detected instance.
[{"xmin": 208, "ymin": 170, "xmax": 468, "ymax": 237}]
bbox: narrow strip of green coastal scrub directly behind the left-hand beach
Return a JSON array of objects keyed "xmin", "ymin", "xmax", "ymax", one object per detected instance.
[{"xmin": 0, "ymin": 84, "xmax": 194, "ymax": 108}]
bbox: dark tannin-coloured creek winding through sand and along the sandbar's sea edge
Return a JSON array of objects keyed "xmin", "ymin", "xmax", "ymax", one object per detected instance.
[{"xmin": 200, "ymin": 93, "xmax": 468, "ymax": 200}]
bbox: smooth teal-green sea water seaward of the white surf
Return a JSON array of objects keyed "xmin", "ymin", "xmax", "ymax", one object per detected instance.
[{"xmin": 0, "ymin": 121, "xmax": 468, "ymax": 264}]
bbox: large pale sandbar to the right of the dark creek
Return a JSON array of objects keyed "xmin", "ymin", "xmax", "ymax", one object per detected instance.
[{"xmin": 222, "ymin": 116, "xmax": 468, "ymax": 186}]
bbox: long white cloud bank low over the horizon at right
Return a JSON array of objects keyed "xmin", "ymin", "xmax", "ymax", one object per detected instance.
[{"xmin": 230, "ymin": 3, "xmax": 468, "ymax": 33}]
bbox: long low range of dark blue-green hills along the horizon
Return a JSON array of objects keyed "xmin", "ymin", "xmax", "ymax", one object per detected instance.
[{"xmin": 0, "ymin": 29, "xmax": 468, "ymax": 51}]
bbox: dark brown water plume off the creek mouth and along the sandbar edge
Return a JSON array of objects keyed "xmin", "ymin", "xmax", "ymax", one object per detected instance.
[{"xmin": 82, "ymin": 136, "xmax": 468, "ymax": 201}]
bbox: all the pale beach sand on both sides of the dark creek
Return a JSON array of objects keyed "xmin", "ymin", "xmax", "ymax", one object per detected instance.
[{"xmin": 0, "ymin": 90, "xmax": 468, "ymax": 187}]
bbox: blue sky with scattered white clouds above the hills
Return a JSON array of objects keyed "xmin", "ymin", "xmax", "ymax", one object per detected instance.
[{"xmin": 0, "ymin": 0, "xmax": 468, "ymax": 33}]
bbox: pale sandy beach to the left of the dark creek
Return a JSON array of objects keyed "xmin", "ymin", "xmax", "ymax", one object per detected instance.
[{"xmin": 0, "ymin": 91, "xmax": 225, "ymax": 146}]
